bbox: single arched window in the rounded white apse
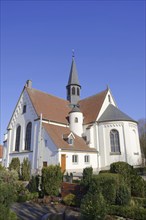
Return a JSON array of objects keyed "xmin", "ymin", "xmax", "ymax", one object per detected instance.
[{"xmin": 110, "ymin": 129, "xmax": 120, "ymax": 153}]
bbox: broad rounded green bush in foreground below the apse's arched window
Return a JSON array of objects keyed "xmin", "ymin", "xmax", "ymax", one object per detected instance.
[{"xmin": 89, "ymin": 173, "xmax": 124, "ymax": 204}]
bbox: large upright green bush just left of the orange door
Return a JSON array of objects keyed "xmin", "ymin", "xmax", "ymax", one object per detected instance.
[{"xmin": 42, "ymin": 165, "xmax": 62, "ymax": 196}]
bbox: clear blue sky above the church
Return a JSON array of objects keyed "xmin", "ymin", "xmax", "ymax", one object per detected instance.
[{"xmin": 0, "ymin": 0, "xmax": 146, "ymax": 143}]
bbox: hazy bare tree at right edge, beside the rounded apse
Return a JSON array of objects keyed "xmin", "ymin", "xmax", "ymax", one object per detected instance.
[{"xmin": 138, "ymin": 119, "xmax": 146, "ymax": 158}]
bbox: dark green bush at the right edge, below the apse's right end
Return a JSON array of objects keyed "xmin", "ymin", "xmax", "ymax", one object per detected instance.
[{"xmin": 131, "ymin": 175, "xmax": 146, "ymax": 197}]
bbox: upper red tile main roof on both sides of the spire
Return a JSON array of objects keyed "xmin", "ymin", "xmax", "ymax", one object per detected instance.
[{"xmin": 26, "ymin": 88, "xmax": 108, "ymax": 124}]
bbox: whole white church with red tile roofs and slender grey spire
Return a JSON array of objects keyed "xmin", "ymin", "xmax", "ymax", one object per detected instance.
[{"xmin": 3, "ymin": 56, "xmax": 141, "ymax": 174}]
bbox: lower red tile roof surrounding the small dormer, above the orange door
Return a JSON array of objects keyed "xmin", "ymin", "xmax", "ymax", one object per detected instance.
[{"xmin": 43, "ymin": 123, "xmax": 96, "ymax": 152}]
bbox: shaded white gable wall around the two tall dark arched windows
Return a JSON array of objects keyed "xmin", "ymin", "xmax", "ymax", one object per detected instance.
[{"xmin": 4, "ymin": 89, "xmax": 37, "ymax": 169}]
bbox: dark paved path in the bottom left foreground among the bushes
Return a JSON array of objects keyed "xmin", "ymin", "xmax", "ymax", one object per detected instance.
[{"xmin": 12, "ymin": 202, "xmax": 65, "ymax": 220}]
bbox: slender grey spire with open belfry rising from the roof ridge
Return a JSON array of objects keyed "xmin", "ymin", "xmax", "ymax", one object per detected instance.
[{"xmin": 66, "ymin": 54, "xmax": 81, "ymax": 106}]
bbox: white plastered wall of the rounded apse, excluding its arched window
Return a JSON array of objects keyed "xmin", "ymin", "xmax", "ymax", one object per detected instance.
[{"xmin": 98, "ymin": 121, "xmax": 141, "ymax": 169}]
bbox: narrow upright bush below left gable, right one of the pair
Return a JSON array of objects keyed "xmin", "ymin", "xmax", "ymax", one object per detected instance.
[{"xmin": 21, "ymin": 158, "xmax": 31, "ymax": 181}]
